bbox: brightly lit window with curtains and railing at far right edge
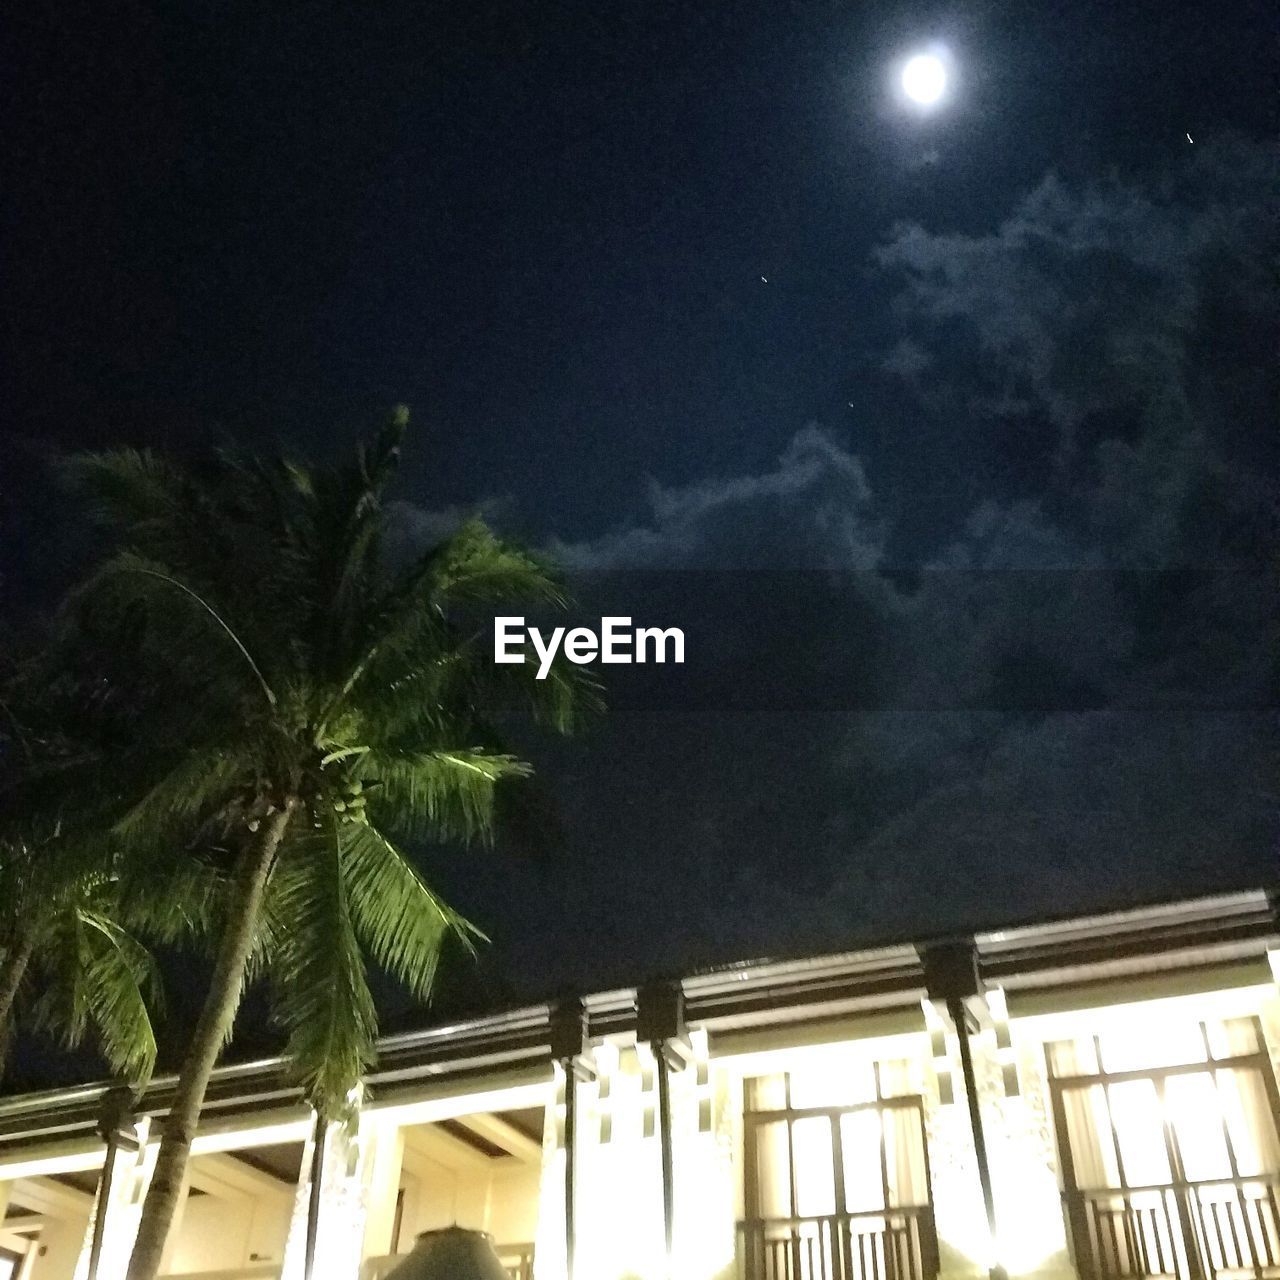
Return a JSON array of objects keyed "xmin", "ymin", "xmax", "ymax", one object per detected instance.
[{"xmin": 1047, "ymin": 1016, "xmax": 1280, "ymax": 1280}]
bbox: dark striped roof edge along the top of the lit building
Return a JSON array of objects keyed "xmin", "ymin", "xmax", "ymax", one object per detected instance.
[{"xmin": 0, "ymin": 890, "xmax": 1280, "ymax": 1151}]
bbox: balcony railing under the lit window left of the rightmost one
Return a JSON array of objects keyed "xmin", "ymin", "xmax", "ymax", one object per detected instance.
[{"xmin": 739, "ymin": 1206, "xmax": 938, "ymax": 1280}]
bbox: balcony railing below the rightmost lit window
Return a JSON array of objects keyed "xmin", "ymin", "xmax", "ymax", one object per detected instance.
[{"xmin": 1066, "ymin": 1178, "xmax": 1280, "ymax": 1280}]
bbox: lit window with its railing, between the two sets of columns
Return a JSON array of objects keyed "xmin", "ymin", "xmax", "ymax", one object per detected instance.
[{"xmin": 741, "ymin": 1062, "xmax": 937, "ymax": 1280}]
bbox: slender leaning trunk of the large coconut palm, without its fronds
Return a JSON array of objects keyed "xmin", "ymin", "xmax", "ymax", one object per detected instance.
[{"xmin": 128, "ymin": 799, "xmax": 297, "ymax": 1280}]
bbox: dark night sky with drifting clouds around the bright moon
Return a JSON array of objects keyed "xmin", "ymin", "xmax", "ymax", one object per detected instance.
[{"xmin": 0, "ymin": 0, "xmax": 1280, "ymax": 1070}]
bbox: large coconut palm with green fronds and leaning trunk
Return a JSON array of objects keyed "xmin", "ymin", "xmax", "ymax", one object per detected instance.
[{"xmin": 62, "ymin": 408, "xmax": 594, "ymax": 1280}]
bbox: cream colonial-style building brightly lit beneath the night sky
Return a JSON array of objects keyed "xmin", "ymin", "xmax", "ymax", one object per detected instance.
[{"xmin": 0, "ymin": 892, "xmax": 1280, "ymax": 1280}]
